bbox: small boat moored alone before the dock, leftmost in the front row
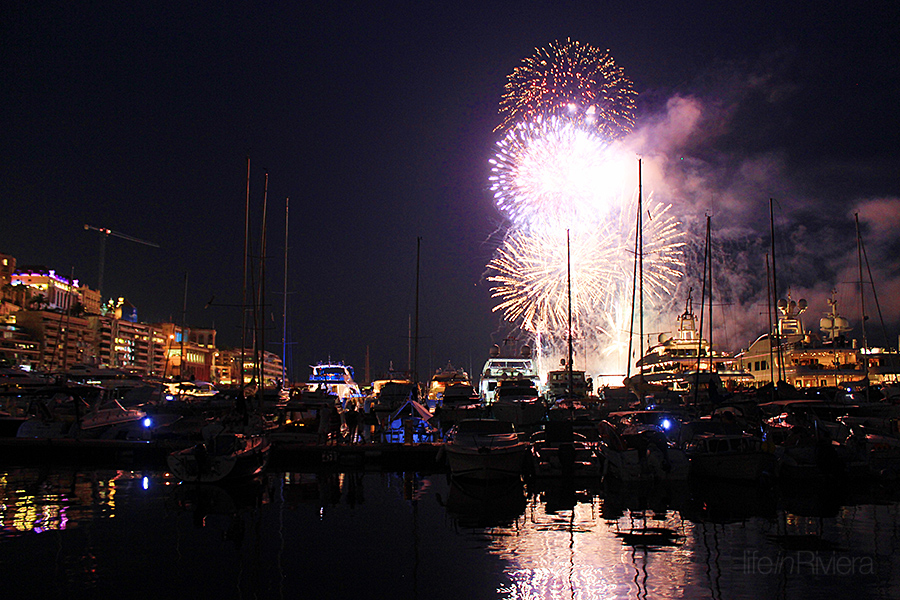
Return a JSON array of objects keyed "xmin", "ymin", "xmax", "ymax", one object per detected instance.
[{"xmin": 166, "ymin": 425, "xmax": 271, "ymax": 483}]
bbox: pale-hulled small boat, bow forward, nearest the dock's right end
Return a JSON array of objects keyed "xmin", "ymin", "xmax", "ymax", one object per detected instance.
[{"xmin": 443, "ymin": 419, "xmax": 528, "ymax": 480}]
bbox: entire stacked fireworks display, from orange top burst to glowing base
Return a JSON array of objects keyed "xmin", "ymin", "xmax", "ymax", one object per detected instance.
[{"xmin": 487, "ymin": 40, "xmax": 684, "ymax": 380}]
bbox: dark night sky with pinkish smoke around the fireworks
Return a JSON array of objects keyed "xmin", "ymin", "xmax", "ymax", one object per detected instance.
[{"xmin": 0, "ymin": 0, "xmax": 900, "ymax": 379}]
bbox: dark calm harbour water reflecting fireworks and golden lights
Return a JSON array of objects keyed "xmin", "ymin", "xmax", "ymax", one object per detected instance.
[{"xmin": 0, "ymin": 468, "xmax": 900, "ymax": 600}]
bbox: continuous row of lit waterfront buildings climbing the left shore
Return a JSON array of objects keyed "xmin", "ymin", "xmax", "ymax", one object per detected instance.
[{"xmin": 0, "ymin": 254, "xmax": 283, "ymax": 387}]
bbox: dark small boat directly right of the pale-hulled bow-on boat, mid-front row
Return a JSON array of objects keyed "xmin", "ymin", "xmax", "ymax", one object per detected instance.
[{"xmin": 531, "ymin": 421, "xmax": 603, "ymax": 477}]
